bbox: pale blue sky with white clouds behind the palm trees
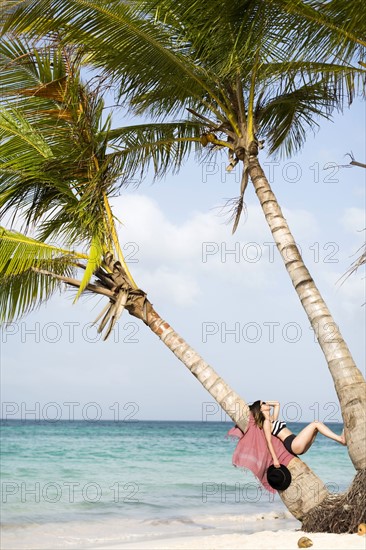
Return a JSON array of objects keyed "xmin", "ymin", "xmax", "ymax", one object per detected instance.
[{"xmin": 1, "ymin": 96, "xmax": 366, "ymax": 421}]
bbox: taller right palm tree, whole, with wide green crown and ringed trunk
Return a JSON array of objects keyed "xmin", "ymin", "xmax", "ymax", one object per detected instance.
[{"xmin": 1, "ymin": 0, "xmax": 366, "ymax": 532}]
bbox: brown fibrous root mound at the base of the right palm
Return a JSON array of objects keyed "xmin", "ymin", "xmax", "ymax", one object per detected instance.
[{"xmin": 302, "ymin": 470, "xmax": 366, "ymax": 533}]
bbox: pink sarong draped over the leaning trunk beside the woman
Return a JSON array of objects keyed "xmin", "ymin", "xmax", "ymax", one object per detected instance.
[{"xmin": 227, "ymin": 414, "xmax": 295, "ymax": 493}]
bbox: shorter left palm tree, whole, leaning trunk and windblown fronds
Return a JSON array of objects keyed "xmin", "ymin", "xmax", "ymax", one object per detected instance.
[{"xmin": 0, "ymin": 39, "xmax": 359, "ymax": 532}]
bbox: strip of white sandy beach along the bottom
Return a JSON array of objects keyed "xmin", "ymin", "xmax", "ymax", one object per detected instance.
[{"xmin": 1, "ymin": 514, "xmax": 366, "ymax": 550}]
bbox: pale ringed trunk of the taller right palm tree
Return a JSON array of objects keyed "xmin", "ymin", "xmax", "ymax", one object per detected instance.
[{"xmin": 249, "ymin": 153, "xmax": 366, "ymax": 470}]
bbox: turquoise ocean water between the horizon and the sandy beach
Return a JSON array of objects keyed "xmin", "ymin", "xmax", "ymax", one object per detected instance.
[{"xmin": 1, "ymin": 420, "xmax": 354, "ymax": 548}]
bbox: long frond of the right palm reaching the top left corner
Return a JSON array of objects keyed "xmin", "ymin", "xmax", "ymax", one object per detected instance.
[{"xmin": 0, "ymin": 0, "xmax": 232, "ymax": 121}]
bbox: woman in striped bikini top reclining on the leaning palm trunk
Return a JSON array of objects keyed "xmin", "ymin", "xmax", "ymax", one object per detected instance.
[{"xmin": 256, "ymin": 400, "xmax": 346, "ymax": 468}]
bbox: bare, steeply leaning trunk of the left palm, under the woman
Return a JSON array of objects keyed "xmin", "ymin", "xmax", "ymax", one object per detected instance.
[{"xmin": 127, "ymin": 298, "xmax": 329, "ymax": 520}]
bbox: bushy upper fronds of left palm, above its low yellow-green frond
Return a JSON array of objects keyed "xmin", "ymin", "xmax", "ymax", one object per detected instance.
[{"xmin": 0, "ymin": 36, "xmax": 142, "ymax": 297}]
